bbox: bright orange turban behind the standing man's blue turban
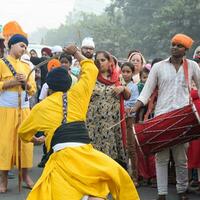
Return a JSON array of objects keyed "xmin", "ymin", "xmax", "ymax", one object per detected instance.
[{"xmin": 3, "ymin": 21, "xmax": 28, "ymax": 39}]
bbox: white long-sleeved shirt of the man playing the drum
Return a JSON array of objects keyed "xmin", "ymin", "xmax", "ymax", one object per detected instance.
[{"xmin": 138, "ymin": 58, "xmax": 200, "ymax": 116}]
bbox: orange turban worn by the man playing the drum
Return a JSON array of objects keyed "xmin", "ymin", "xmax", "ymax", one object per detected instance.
[{"xmin": 171, "ymin": 33, "xmax": 194, "ymax": 49}]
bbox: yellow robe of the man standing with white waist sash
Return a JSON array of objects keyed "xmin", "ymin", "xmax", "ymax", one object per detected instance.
[{"xmin": 0, "ymin": 56, "xmax": 36, "ymax": 170}]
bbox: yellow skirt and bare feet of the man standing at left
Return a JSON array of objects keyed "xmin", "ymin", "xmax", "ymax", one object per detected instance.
[{"xmin": 0, "ymin": 108, "xmax": 33, "ymax": 193}]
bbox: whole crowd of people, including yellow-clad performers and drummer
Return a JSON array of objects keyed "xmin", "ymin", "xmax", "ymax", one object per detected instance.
[{"xmin": 0, "ymin": 20, "xmax": 200, "ymax": 200}]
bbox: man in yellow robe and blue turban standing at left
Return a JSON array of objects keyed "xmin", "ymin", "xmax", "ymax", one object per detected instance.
[{"xmin": 0, "ymin": 34, "xmax": 36, "ymax": 193}]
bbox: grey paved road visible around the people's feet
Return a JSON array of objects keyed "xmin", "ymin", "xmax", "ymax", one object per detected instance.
[{"xmin": 0, "ymin": 146, "xmax": 200, "ymax": 200}]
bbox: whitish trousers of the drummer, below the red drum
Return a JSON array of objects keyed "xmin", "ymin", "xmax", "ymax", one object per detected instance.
[{"xmin": 156, "ymin": 144, "xmax": 188, "ymax": 195}]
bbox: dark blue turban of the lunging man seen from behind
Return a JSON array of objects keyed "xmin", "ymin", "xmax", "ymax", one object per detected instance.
[{"xmin": 46, "ymin": 67, "xmax": 72, "ymax": 92}]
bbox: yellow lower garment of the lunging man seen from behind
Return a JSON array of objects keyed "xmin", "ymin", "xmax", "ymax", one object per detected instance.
[{"xmin": 27, "ymin": 144, "xmax": 139, "ymax": 200}]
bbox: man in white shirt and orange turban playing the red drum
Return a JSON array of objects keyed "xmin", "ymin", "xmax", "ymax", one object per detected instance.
[{"xmin": 130, "ymin": 34, "xmax": 200, "ymax": 200}]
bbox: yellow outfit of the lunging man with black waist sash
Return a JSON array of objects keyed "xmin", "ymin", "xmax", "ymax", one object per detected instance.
[{"xmin": 19, "ymin": 60, "xmax": 139, "ymax": 200}]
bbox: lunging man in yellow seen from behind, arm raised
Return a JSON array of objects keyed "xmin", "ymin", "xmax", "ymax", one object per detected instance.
[{"xmin": 18, "ymin": 45, "xmax": 139, "ymax": 200}]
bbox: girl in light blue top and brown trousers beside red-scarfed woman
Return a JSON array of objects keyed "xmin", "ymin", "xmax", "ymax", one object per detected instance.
[{"xmin": 121, "ymin": 62, "xmax": 139, "ymax": 187}]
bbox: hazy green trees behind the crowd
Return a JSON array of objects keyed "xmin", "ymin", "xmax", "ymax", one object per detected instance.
[{"xmin": 45, "ymin": 0, "xmax": 200, "ymax": 59}]
